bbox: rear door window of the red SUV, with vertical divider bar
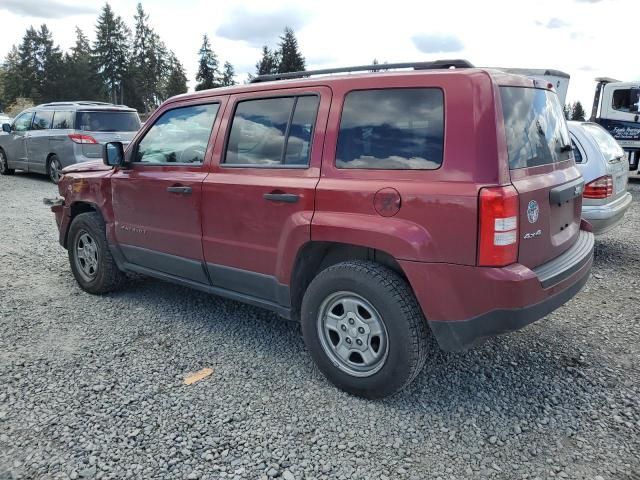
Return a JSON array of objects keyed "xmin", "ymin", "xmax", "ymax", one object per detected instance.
[{"xmin": 224, "ymin": 95, "xmax": 320, "ymax": 167}]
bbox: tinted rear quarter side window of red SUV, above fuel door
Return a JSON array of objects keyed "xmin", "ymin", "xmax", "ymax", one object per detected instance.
[{"xmin": 336, "ymin": 88, "xmax": 444, "ymax": 170}]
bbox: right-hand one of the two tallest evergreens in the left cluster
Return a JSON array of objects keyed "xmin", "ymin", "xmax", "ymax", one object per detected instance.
[{"xmin": 129, "ymin": 3, "xmax": 169, "ymax": 112}]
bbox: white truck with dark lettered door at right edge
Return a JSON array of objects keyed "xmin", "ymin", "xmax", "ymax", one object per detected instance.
[{"xmin": 589, "ymin": 77, "xmax": 640, "ymax": 173}]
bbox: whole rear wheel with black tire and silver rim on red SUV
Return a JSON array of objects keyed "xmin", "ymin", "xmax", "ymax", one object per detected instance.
[{"xmin": 301, "ymin": 260, "xmax": 429, "ymax": 399}]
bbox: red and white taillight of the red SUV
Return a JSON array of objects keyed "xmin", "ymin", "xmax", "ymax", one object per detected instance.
[{"xmin": 478, "ymin": 185, "xmax": 519, "ymax": 267}]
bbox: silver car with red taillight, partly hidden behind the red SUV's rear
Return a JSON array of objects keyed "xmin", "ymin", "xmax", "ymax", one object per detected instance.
[{"xmin": 567, "ymin": 122, "xmax": 632, "ymax": 234}]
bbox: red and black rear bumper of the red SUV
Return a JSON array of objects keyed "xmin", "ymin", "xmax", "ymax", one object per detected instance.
[{"xmin": 400, "ymin": 230, "xmax": 594, "ymax": 351}]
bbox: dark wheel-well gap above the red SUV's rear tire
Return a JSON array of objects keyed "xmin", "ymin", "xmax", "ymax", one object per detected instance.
[{"xmin": 289, "ymin": 241, "xmax": 407, "ymax": 320}]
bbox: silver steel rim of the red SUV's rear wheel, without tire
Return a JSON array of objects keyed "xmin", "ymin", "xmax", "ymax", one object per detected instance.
[{"xmin": 318, "ymin": 292, "xmax": 389, "ymax": 377}]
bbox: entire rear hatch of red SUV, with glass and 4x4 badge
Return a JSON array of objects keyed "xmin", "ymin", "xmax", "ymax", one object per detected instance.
[{"xmin": 500, "ymin": 86, "xmax": 584, "ymax": 268}]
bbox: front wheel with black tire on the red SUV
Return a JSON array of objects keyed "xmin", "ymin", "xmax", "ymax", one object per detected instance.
[{"xmin": 68, "ymin": 212, "xmax": 126, "ymax": 294}]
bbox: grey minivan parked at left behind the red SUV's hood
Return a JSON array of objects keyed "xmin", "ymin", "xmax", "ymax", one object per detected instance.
[{"xmin": 0, "ymin": 102, "xmax": 140, "ymax": 183}]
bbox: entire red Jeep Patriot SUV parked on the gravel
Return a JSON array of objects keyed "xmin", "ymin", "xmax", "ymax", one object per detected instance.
[{"xmin": 52, "ymin": 61, "xmax": 593, "ymax": 398}]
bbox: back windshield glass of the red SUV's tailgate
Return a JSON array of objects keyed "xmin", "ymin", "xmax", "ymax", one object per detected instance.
[{"xmin": 500, "ymin": 87, "xmax": 572, "ymax": 170}]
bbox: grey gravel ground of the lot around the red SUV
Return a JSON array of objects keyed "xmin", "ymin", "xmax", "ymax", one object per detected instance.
[{"xmin": 0, "ymin": 174, "xmax": 640, "ymax": 480}]
